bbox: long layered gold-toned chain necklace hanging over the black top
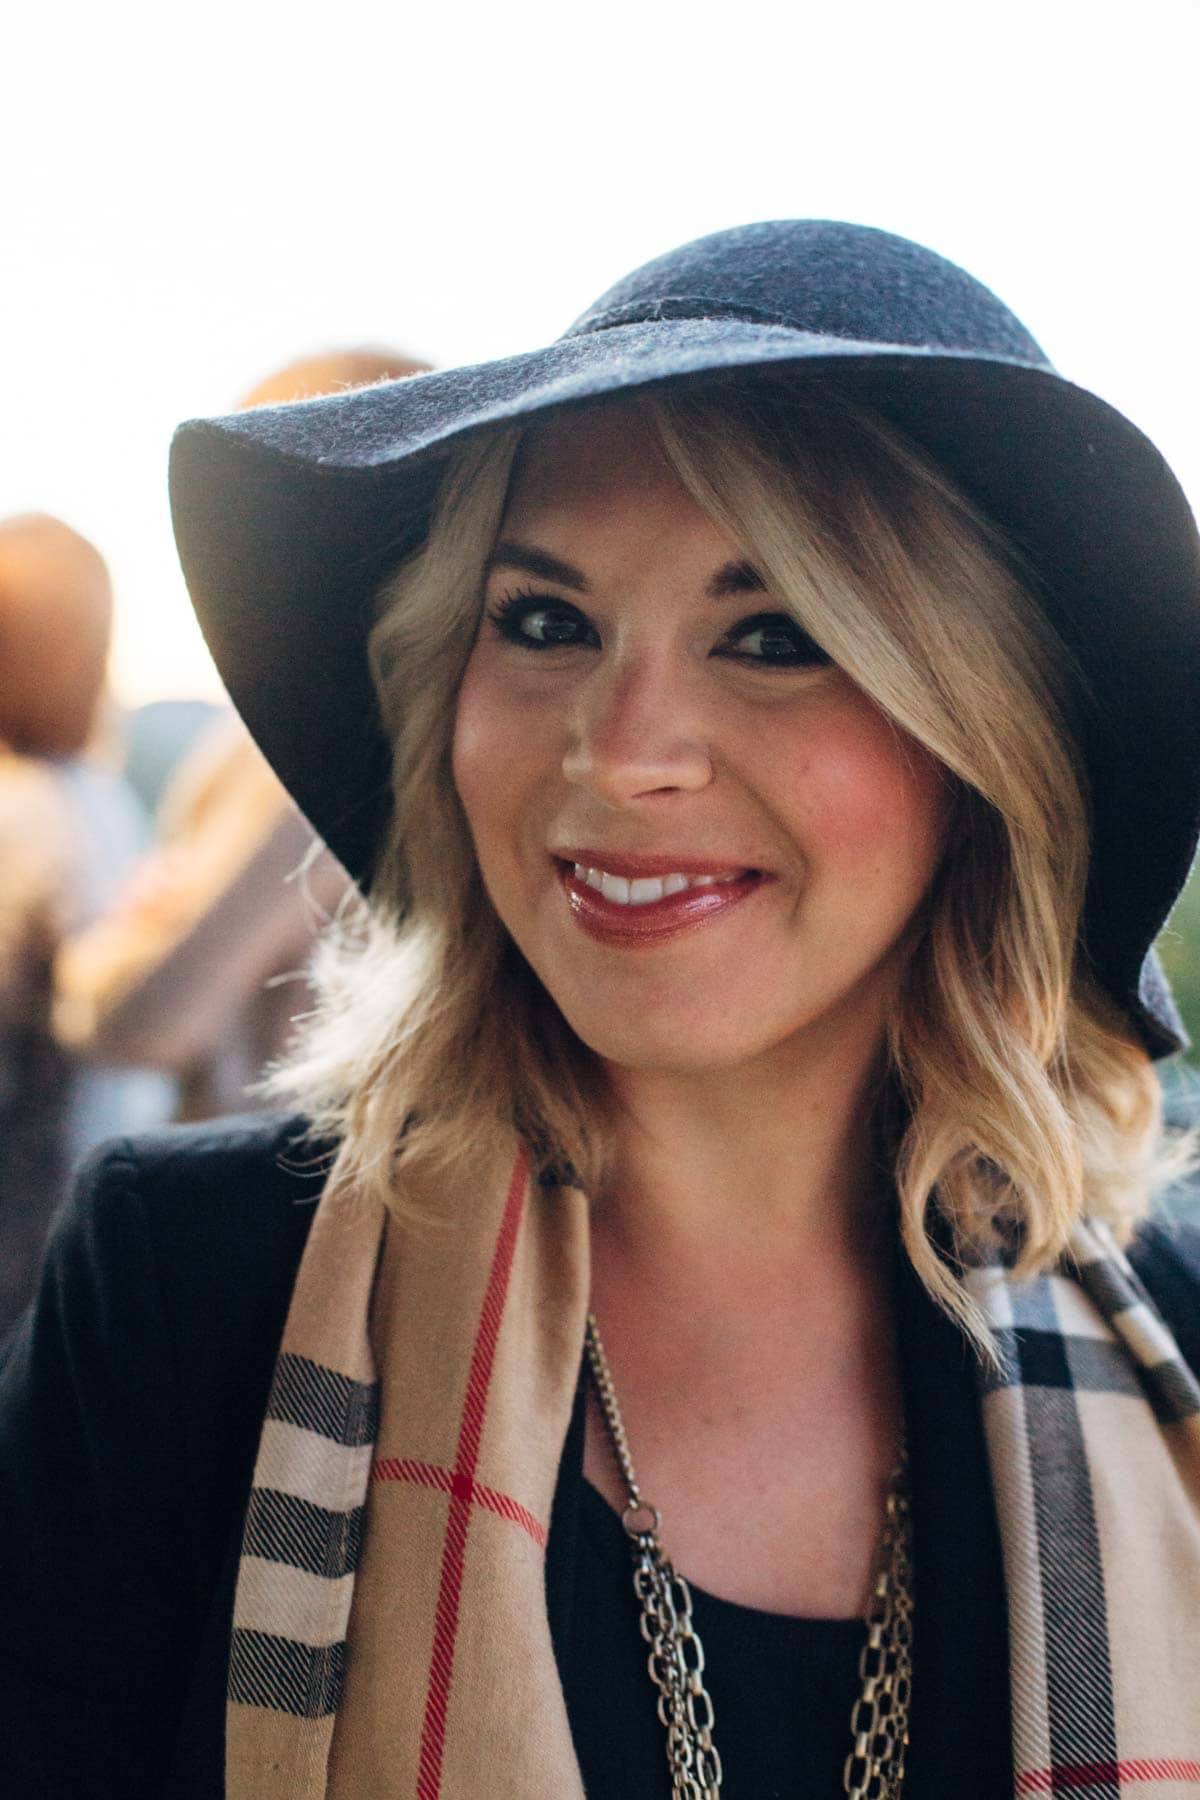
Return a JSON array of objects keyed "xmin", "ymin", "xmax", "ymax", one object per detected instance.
[{"xmin": 587, "ymin": 1314, "xmax": 912, "ymax": 1800}]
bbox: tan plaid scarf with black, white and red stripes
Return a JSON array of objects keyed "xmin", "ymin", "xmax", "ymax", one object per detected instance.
[{"xmin": 227, "ymin": 1152, "xmax": 1200, "ymax": 1800}]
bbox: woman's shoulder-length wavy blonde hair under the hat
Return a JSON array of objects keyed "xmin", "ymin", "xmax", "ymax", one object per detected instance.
[{"xmin": 272, "ymin": 378, "xmax": 1177, "ymax": 1346}]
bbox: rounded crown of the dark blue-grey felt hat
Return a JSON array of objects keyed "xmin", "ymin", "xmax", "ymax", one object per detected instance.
[{"xmin": 565, "ymin": 220, "xmax": 1049, "ymax": 369}]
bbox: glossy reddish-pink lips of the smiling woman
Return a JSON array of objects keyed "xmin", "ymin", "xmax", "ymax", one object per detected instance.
[{"xmin": 554, "ymin": 851, "xmax": 770, "ymax": 950}]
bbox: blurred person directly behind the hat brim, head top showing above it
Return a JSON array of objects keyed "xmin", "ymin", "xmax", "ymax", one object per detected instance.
[{"xmin": 54, "ymin": 349, "xmax": 426, "ymax": 1120}]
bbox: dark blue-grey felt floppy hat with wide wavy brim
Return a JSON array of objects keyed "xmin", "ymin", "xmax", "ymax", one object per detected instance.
[{"xmin": 171, "ymin": 220, "xmax": 1200, "ymax": 1055}]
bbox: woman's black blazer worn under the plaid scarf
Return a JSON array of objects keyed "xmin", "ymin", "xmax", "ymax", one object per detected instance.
[{"xmin": 0, "ymin": 1118, "xmax": 1200, "ymax": 1800}]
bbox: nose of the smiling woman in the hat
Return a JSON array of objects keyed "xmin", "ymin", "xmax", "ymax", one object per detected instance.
[{"xmin": 563, "ymin": 664, "xmax": 712, "ymax": 806}]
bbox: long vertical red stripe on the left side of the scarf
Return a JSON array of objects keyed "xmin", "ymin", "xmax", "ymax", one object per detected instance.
[{"xmin": 417, "ymin": 1150, "xmax": 527, "ymax": 1800}]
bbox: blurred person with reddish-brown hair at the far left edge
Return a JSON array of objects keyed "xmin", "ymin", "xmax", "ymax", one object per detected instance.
[{"xmin": 0, "ymin": 513, "xmax": 175, "ymax": 1332}]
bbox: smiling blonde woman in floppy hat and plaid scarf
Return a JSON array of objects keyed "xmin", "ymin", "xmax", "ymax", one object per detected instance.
[{"xmin": 5, "ymin": 223, "xmax": 1200, "ymax": 1800}]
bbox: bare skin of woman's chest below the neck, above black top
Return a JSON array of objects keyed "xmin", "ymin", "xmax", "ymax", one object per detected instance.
[{"xmin": 583, "ymin": 1255, "xmax": 901, "ymax": 1618}]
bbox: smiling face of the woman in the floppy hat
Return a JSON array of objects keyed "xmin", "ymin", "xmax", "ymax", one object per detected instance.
[{"xmin": 453, "ymin": 405, "xmax": 948, "ymax": 1071}]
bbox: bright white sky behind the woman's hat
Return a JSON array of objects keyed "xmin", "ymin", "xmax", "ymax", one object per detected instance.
[{"xmin": 0, "ymin": 0, "xmax": 1200, "ymax": 702}]
